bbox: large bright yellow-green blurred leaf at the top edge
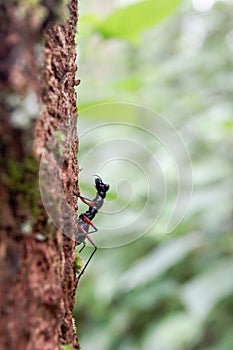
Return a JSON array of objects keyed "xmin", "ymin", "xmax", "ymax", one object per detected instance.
[{"xmin": 98, "ymin": 0, "xmax": 181, "ymax": 39}]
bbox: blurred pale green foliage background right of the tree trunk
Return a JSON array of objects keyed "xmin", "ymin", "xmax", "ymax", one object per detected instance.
[{"xmin": 74, "ymin": 0, "xmax": 233, "ymax": 350}]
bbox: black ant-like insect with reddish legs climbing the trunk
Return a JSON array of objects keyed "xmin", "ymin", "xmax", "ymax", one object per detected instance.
[{"xmin": 76, "ymin": 175, "xmax": 109, "ymax": 285}]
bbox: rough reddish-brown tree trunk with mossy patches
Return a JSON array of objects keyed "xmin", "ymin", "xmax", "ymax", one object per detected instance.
[{"xmin": 0, "ymin": 0, "xmax": 79, "ymax": 350}]
